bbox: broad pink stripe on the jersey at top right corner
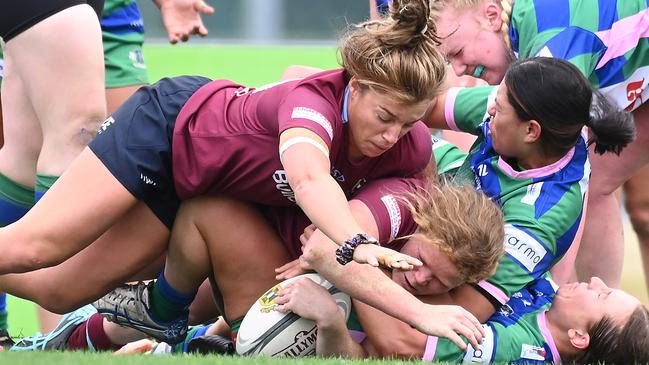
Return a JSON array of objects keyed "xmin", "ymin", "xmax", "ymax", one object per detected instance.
[{"xmin": 595, "ymin": 9, "xmax": 649, "ymax": 69}]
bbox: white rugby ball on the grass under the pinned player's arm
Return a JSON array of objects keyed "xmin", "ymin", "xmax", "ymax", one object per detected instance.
[{"xmin": 236, "ymin": 274, "xmax": 351, "ymax": 357}]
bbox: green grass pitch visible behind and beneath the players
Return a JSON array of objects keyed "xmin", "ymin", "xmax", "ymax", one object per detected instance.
[{"xmin": 5, "ymin": 45, "xmax": 649, "ymax": 365}]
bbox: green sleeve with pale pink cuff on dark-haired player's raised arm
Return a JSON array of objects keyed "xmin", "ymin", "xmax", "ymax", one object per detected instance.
[{"xmin": 444, "ymin": 86, "xmax": 498, "ymax": 135}]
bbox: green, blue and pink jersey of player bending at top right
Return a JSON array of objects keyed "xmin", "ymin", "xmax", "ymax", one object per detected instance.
[{"xmin": 509, "ymin": 0, "xmax": 649, "ymax": 110}]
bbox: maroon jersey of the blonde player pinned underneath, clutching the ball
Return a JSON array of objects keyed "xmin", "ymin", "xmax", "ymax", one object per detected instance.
[{"xmin": 264, "ymin": 178, "xmax": 421, "ymax": 259}]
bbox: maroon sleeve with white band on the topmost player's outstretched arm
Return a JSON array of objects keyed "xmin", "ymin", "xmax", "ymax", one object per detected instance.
[{"xmin": 277, "ymin": 84, "xmax": 340, "ymax": 149}]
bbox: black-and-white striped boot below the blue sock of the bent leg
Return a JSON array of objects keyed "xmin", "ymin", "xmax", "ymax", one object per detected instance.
[{"xmin": 92, "ymin": 281, "xmax": 189, "ymax": 345}]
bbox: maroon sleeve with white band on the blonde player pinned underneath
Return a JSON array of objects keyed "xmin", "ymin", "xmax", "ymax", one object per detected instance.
[{"xmin": 354, "ymin": 178, "xmax": 421, "ymax": 247}]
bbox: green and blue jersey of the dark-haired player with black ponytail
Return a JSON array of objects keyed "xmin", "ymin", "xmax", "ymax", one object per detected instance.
[{"xmin": 433, "ymin": 87, "xmax": 590, "ymax": 304}]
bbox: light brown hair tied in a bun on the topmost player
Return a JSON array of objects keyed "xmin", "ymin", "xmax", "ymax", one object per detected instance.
[{"xmin": 340, "ymin": 0, "xmax": 446, "ymax": 103}]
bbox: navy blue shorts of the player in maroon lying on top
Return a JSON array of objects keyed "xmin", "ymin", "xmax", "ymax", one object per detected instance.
[{"xmin": 89, "ymin": 76, "xmax": 211, "ymax": 230}]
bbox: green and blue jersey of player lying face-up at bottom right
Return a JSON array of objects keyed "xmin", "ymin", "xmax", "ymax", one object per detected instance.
[{"xmin": 423, "ymin": 279, "xmax": 561, "ymax": 365}]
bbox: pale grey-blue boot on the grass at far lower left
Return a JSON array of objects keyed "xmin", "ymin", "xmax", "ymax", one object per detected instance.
[{"xmin": 11, "ymin": 305, "xmax": 97, "ymax": 351}]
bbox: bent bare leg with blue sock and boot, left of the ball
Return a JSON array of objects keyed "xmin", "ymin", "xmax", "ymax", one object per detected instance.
[{"xmin": 95, "ymin": 197, "xmax": 290, "ymax": 342}]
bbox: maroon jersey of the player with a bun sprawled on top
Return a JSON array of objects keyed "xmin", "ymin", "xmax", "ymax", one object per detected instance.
[{"xmin": 172, "ymin": 70, "xmax": 432, "ymax": 206}]
